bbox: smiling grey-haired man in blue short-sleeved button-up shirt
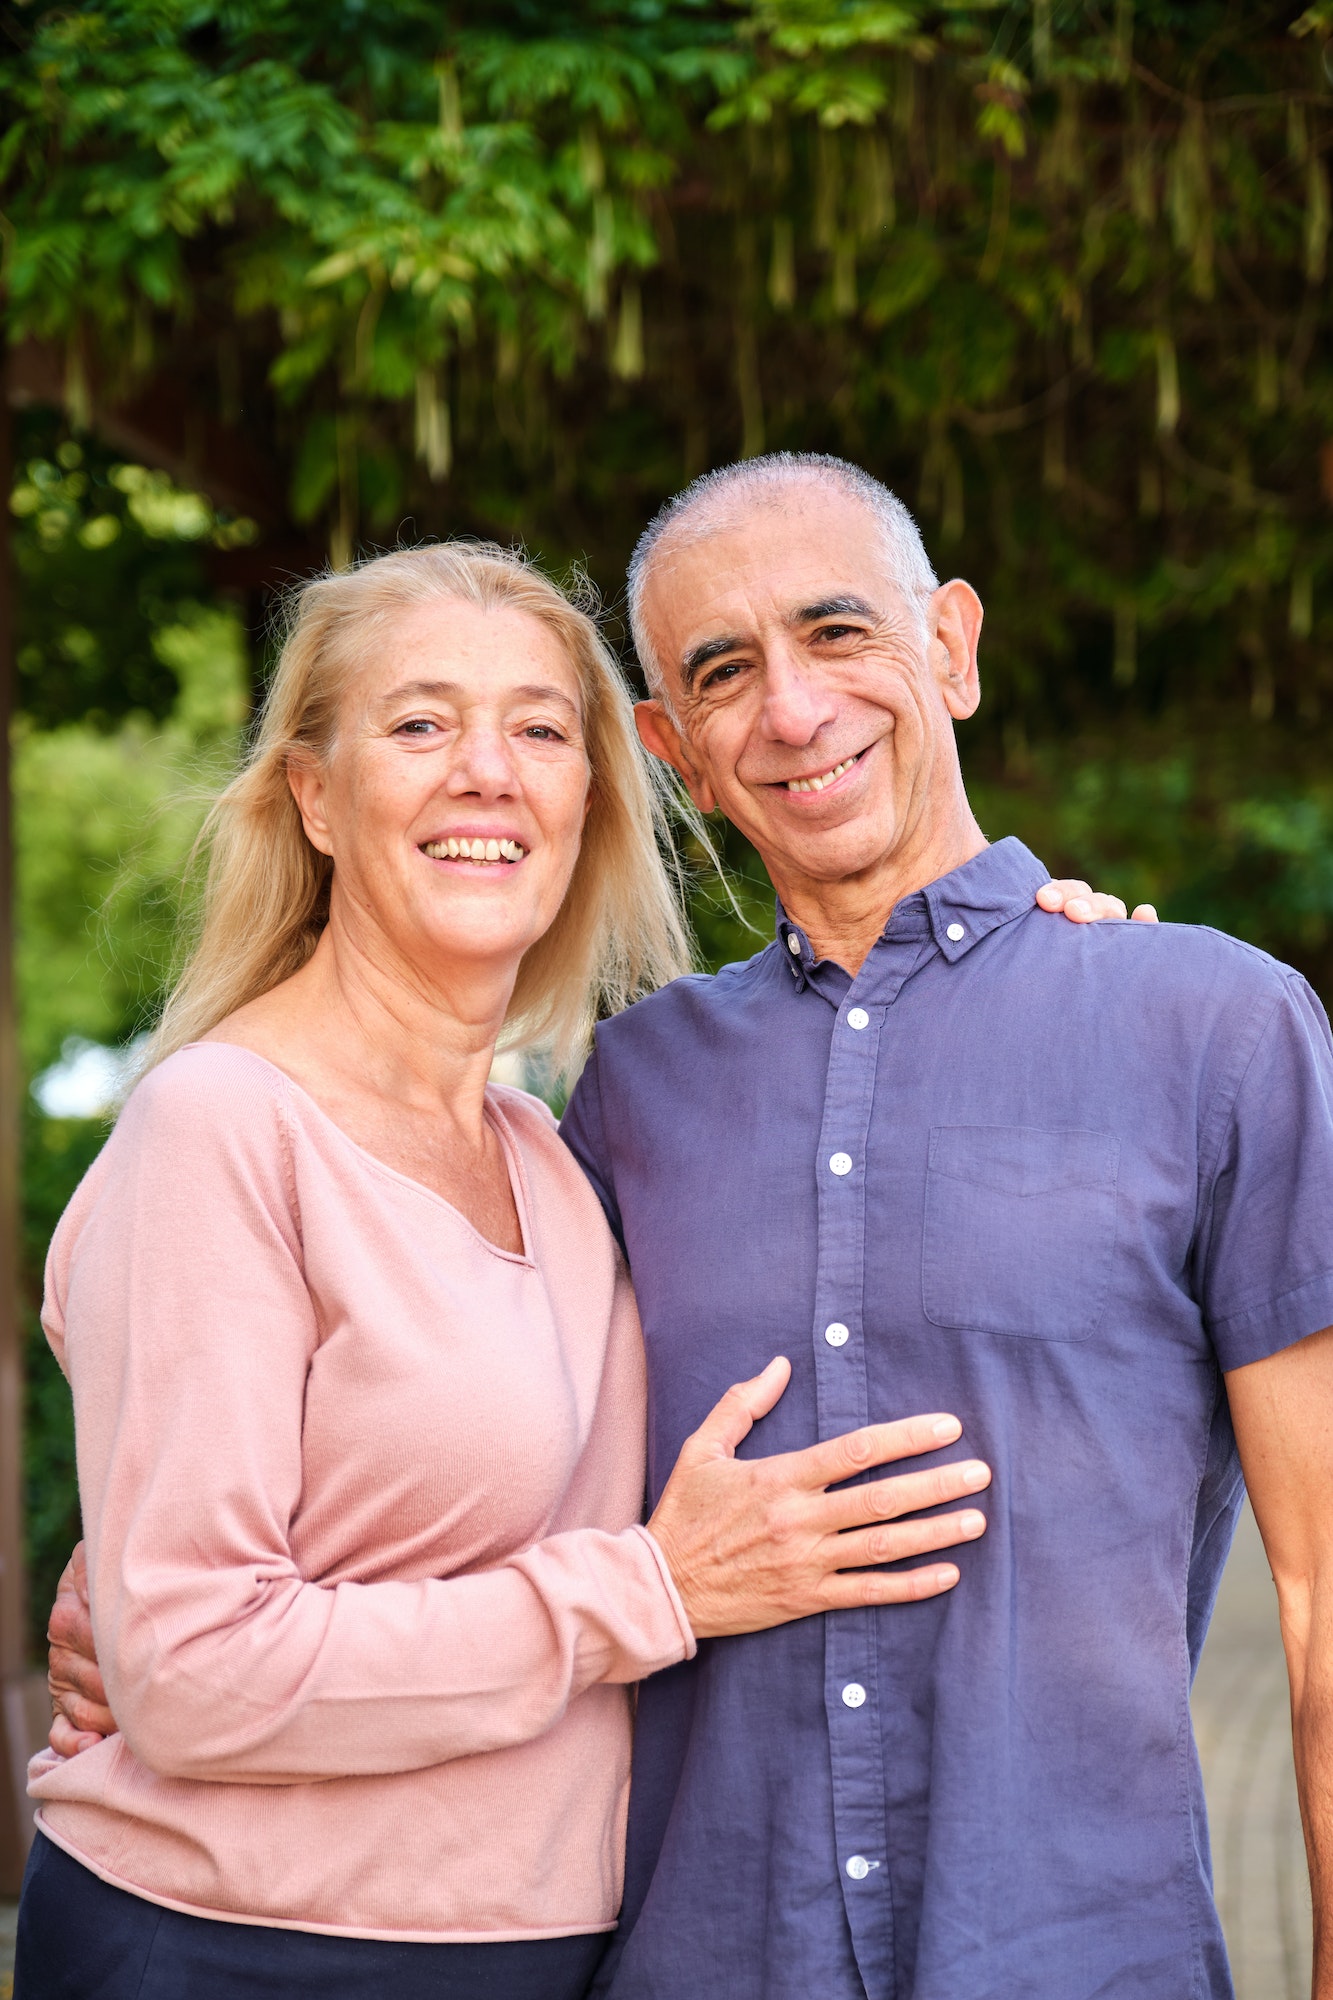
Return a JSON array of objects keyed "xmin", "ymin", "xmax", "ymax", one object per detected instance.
[{"xmin": 564, "ymin": 456, "xmax": 1333, "ymax": 2000}]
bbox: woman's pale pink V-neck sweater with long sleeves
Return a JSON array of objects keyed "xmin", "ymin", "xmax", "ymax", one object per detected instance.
[{"xmin": 30, "ymin": 1042, "xmax": 695, "ymax": 1942}]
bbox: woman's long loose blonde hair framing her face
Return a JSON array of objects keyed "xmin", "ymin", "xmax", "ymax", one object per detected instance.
[{"xmin": 146, "ymin": 542, "xmax": 689, "ymax": 1068}]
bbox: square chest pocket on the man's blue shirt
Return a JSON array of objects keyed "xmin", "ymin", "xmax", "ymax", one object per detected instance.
[{"xmin": 921, "ymin": 1126, "xmax": 1121, "ymax": 1340}]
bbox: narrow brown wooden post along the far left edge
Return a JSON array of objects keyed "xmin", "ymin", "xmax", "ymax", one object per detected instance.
[{"xmin": 0, "ymin": 334, "xmax": 32, "ymax": 1896}]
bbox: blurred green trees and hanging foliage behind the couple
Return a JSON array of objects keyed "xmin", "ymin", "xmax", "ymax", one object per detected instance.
[{"xmin": 0, "ymin": 0, "xmax": 1333, "ymax": 1644}]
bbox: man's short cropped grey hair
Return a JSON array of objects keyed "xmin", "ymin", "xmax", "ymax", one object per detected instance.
[{"xmin": 628, "ymin": 452, "xmax": 939, "ymax": 696}]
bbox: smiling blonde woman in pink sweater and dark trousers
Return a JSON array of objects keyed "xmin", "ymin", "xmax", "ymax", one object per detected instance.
[{"xmin": 18, "ymin": 546, "xmax": 1008, "ymax": 2000}]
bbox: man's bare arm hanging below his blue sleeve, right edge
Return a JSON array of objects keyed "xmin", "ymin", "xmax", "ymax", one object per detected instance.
[{"xmin": 1227, "ymin": 1326, "xmax": 1333, "ymax": 2000}]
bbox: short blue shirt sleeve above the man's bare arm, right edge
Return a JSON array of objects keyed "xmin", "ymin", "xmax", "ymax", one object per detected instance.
[{"xmin": 1195, "ymin": 972, "xmax": 1333, "ymax": 1368}]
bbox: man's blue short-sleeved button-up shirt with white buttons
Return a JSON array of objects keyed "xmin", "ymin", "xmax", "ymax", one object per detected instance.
[{"xmin": 564, "ymin": 840, "xmax": 1333, "ymax": 2000}]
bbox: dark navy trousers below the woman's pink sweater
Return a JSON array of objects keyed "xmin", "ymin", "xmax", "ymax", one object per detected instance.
[{"xmin": 14, "ymin": 1834, "xmax": 608, "ymax": 2000}]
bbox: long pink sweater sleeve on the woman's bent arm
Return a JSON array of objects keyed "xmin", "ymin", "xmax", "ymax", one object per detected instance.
[{"xmin": 44, "ymin": 1048, "xmax": 695, "ymax": 1784}]
